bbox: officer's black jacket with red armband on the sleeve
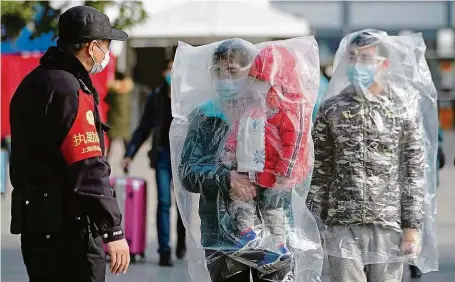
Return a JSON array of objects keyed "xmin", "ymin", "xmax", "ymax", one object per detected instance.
[{"xmin": 10, "ymin": 47, "xmax": 123, "ymax": 242}]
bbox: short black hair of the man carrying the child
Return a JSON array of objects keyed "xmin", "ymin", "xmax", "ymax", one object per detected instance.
[{"xmin": 213, "ymin": 38, "xmax": 254, "ymax": 67}]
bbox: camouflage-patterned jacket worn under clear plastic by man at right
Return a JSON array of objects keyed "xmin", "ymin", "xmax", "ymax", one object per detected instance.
[{"xmin": 307, "ymin": 86, "xmax": 425, "ymax": 230}]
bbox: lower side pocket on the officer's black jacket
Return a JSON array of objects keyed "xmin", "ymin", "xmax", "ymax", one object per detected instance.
[{"xmin": 23, "ymin": 187, "xmax": 63, "ymax": 233}]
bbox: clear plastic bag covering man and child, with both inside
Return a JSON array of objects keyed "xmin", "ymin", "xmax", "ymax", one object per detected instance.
[{"xmin": 170, "ymin": 37, "xmax": 323, "ymax": 281}]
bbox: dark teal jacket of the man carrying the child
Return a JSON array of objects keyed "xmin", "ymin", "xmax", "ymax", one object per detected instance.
[{"xmin": 178, "ymin": 109, "xmax": 230, "ymax": 243}]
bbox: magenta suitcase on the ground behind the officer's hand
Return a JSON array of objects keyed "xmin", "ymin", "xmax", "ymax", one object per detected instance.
[{"xmin": 104, "ymin": 177, "xmax": 147, "ymax": 262}]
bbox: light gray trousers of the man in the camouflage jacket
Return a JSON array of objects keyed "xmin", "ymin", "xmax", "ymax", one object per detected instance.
[{"xmin": 326, "ymin": 225, "xmax": 403, "ymax": 282}]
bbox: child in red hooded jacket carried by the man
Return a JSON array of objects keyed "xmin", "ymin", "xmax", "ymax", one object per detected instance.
[{"xmin": 222, "ymin": 46, "xmax": 312, "ymax": 266}]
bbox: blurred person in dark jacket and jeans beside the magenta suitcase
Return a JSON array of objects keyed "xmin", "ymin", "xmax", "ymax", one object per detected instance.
[{"xmin": 121, "ymin": 60, "xmax": 186, "ymax": 266}]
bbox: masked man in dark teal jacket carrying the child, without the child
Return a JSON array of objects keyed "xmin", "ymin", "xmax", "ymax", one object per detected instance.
[{"xmin": 179, "ymin": 40, "xmax": 266, "ymax": 281}]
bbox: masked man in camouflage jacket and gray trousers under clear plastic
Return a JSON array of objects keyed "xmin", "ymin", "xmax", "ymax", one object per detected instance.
[{"xmin": 307, "ymin": 30, "xmax": 432, "ymax": 282}]
